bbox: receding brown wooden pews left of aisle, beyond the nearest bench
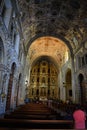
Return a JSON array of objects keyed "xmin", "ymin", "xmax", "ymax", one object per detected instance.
[{"xmin": 4, "ymin": 103, "xmax": 56, "ymax": 120}]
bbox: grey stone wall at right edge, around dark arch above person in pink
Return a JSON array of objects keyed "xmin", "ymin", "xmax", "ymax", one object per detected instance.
[{"xmin": 74, "ymin": 45, "xmax": 87, "ymax": 103}]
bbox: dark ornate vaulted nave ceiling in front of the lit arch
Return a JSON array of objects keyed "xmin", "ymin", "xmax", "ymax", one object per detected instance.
[{"xmin": 18, "ymin": 0, "xmax": 87, "ymax": 68}]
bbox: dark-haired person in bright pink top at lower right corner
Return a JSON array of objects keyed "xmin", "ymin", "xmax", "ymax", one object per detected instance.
[{"xmin": 73, "ymin": 105, "xmax": 86, "ymax": 129}]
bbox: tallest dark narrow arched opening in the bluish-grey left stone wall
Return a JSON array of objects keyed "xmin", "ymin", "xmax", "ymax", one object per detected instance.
[{"xmin": 6, "ymin": 62, "xmax": 16, "ymax": 111}]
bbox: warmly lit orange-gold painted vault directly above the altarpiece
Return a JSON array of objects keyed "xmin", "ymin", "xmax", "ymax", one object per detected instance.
[{"xmin": 28, "ymin": 37, "xmax": 69, "ymax": 67}]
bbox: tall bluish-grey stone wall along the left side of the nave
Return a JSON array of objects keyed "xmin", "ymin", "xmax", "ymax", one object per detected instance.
[{"xmin": 0, "ymin": 0, "xmax": 25, "ymax": 114}]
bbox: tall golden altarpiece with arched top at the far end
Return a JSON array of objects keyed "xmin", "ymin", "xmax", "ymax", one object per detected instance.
[{"xmin": 29, "ymin": 60, "xmax": 58, "ymax": 101}]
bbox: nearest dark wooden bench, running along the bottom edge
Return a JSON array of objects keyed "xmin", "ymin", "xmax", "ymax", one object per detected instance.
[{"xmin": 0, "ymin": 119, "xmax": 73, "ymax": 129}]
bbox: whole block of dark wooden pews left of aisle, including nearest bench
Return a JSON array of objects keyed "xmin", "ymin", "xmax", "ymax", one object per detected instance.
[{"xmin": 0, "ymin": 103, "xmax": 73, "ymax": 130}]
